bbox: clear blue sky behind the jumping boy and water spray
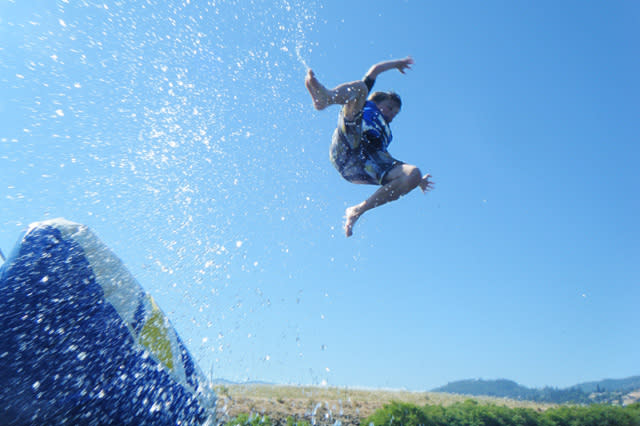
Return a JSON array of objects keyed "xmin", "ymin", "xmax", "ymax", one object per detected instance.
[{"xmin": 0, "ymin": 0, "xmax": 640, "ymax": 390}]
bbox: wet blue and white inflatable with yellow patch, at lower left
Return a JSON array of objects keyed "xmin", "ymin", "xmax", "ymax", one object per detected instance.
[{"xmin": 0, "ymin": 219, "xmax": 216, "ymax": 425}]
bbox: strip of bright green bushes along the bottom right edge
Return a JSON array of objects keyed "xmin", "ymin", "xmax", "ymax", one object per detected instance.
[{"xmin": 361, "ymin": 400, "xmax": 640, "ymax": 426}]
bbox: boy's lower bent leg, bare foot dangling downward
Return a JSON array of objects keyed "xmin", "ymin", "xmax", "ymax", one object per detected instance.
[{"xmin": 344, "ymin": 164, "xmax": 429, "ymax": 237}]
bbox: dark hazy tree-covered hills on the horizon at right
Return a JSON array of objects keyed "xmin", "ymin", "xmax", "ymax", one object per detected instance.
[{"xmin": 433, "ymin": 376, "xmax": 640, "ymax": 404}]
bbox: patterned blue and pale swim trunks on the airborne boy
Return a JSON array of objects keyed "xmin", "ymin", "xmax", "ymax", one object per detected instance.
[{"xmin": 329, "ymin": 110, "xmax": 400, "ymax": 185}]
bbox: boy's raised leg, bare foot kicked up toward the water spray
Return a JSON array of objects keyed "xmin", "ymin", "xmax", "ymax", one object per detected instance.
[{"xmin": 304, "ymin": 70, "xmax": 369, "ymax": 120}]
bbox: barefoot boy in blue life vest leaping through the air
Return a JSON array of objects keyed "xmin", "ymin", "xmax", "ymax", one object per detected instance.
[{"xmin": 305, "ymin": 57, "xmax": 433, "ymax": 237}]
